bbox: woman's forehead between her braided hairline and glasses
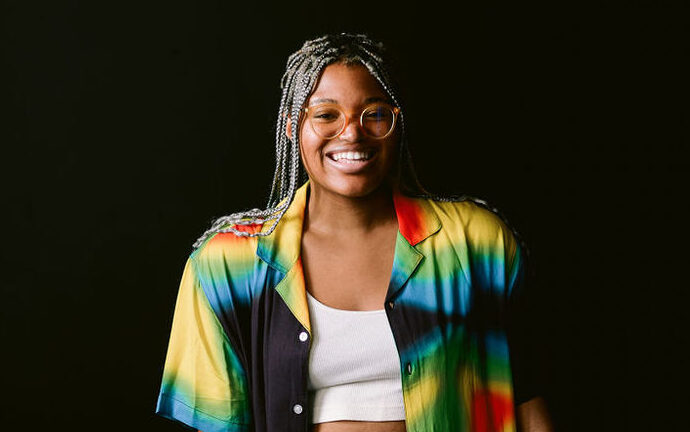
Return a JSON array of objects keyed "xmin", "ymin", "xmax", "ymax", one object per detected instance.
[{"xmin": 309, "ymin": 63, "xmax": 387, "ymax": 104}]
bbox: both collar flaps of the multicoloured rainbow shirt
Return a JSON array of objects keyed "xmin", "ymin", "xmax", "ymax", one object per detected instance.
[{"xmin": 256, "ymin": 180, "xmax": 441, "ymax": 273}]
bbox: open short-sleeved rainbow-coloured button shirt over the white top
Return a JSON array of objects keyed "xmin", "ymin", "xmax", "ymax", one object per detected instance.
[{"xmin": 156, "ymin": 182, "xmax": 533, "ymax": 432}]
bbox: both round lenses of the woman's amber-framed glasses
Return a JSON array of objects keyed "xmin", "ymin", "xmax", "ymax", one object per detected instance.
[{"xmin": 309, "ymin": 105, "xmax": 395, "ymax": 138}]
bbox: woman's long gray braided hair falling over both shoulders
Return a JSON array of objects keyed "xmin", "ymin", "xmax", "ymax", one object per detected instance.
[{"xmin": 188, "ymin": 33, "xmax": 519, "ymax": 256}]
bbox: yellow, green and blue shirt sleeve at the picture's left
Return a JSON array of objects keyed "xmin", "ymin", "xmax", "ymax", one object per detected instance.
[{"xmin": 156, "ymin": 257, "xmax": 250, "ymax": 432}]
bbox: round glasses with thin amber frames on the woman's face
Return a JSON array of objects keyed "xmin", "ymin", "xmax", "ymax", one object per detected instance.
[{"xmin": 303, "ymin": 102, "xmax": 400, "ymax": 139}]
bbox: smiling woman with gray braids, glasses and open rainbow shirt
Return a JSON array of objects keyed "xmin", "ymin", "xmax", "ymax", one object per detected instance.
[{"xmin": 157, "ymin": 34, "xmax": 550, "ymax": 432}]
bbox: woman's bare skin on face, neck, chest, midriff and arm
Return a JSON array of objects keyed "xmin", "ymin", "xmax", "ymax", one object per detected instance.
[{"xmin": 288, "ymin": 63, "xmax": 553, "ymax": 432}]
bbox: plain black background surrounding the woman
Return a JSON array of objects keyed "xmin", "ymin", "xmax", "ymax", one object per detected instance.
[{"xmin": 0, "ymin": 1, "xmax": 688, "ymax": 431}]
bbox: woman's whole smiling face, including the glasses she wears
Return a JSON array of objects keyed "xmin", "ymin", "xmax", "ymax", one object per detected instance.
[{"xmin": 288, "ymin": 63, "xmax": 399, "ymax": 199}]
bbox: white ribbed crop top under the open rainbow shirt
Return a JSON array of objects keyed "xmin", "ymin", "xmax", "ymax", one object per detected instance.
[{"xmin": 307, "ymin": 291, "xmax": 405, "ymax": 423}]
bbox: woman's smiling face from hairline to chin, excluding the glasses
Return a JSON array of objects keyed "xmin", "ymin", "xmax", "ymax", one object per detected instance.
[{"xmin": 292, "ymin": 63, "xmax": 398, "ymax": 198}]
